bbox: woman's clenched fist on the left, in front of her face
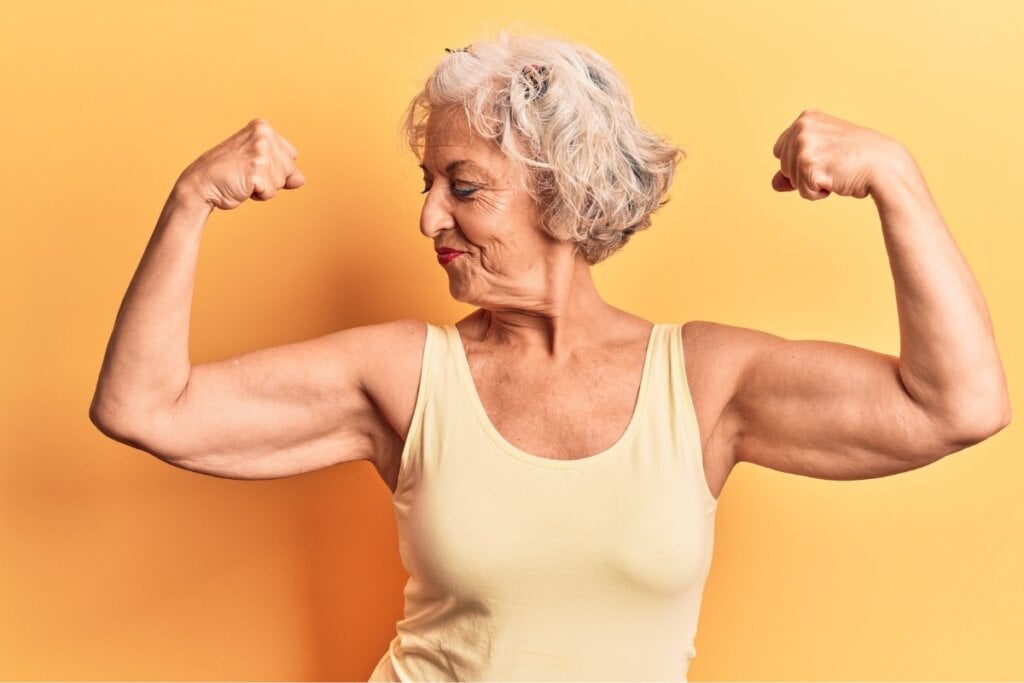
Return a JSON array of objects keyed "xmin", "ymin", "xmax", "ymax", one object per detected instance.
[{"xmin": 176, "ymin": 119, "xmax": 306, "ymax": 210}]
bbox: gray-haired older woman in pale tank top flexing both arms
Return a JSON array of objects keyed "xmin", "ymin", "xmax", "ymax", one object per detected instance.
[{"xmin": 90, "ymin": 35, "xmax": 1011, "ymax": 680}]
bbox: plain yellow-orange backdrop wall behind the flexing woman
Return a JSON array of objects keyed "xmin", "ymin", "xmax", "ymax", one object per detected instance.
[{"xmin": 0, "ymin": 0, "xmax": 1024, "ymax": 680}]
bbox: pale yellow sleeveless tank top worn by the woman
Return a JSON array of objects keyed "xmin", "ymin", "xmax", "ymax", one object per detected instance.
[{"xmin": 370, "ymin": 324, "xmax": 718, "ymax": 681}]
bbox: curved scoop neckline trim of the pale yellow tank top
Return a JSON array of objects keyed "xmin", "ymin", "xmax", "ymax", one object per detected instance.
[{"xmin": 445, "ymin": 323, "xmax": 664, "ymax": 469}]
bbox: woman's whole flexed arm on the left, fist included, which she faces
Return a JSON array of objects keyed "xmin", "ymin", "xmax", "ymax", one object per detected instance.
[{"xmin": 89, "ymin": 119, "xmax": 416, "ymax": 478}]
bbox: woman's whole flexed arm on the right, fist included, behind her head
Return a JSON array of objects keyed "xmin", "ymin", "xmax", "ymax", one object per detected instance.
[{"xmin": 724, "ymin": 110, "xmax": 1011, "ymax": 479}]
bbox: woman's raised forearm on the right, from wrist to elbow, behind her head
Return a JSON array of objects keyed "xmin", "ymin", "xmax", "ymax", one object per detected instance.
[{"xmin": 871, "ymin": 152, "xmax": 1010, "ymax": 439}]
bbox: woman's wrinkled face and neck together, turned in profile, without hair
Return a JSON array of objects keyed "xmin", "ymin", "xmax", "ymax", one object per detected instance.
[{"xmin": 420, "ymin": 108, "xmax": 623, "ymax": 361}]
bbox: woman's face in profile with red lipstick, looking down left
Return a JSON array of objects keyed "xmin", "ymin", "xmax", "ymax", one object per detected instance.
[{"xmin": 420, "ymin": 113, "xmax": 571, "ymax": 309}]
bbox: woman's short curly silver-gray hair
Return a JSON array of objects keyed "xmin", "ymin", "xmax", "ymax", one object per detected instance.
[{"xmin": 403, "ymin": 32, "xmax": 686, "ymax": 265}]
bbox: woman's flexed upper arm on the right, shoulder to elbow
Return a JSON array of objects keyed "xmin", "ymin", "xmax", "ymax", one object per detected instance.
[{"xmin": 715, "ymin": 325, "xmax": 968, "ymax": 479}]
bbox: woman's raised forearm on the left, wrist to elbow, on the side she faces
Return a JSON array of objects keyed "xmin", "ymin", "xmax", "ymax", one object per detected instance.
[{"xmin": 90, "ymin": 185, "xmax": 212, "ymax": 432}]
